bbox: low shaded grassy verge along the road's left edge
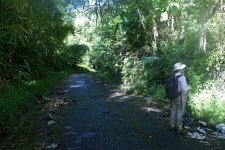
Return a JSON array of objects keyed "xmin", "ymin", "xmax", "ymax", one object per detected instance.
[{"xmin": 0, "ymin": 68, "xmax": 84, "ymax": 137}]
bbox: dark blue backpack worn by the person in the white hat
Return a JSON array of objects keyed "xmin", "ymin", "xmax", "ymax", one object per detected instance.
[{"xmin": 165, "ymin": 75, "xmax": 182, "ymax": 100}]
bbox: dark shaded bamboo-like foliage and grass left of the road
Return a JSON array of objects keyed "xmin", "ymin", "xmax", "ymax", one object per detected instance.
[{"xmin": 0, "ymin": 0, "xmax": 88, "ymax": 134}]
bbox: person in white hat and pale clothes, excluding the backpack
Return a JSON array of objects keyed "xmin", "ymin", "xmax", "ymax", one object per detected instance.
[{"xmin": 170, "ymin": 62, "xmax": 188, "ymax": 133}]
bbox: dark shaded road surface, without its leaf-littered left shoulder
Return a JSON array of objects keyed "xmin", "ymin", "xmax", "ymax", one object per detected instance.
[{"xmin": 50, "ymin": 74, "xmax": 215, "ymax": 150}]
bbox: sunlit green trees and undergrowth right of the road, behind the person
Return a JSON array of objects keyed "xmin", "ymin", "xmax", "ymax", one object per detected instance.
[{"xmin": 85, "ymin": 0, "xmax": 225, "ymax": 122}]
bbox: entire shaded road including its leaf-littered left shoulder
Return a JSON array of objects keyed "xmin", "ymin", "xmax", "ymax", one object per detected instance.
[{"xmin": 0, "ymin": 73, "xmax": 225, "ymax": 150}]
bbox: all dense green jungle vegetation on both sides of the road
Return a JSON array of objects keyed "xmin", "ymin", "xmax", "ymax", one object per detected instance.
[{"xmin": 0, "ymin": 0, "xmax": 225, "ymax": 135}]
